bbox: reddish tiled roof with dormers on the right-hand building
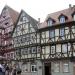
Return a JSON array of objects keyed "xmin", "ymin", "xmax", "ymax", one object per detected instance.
[{"xmin": 40, "ymin": 6, "xmax": 75, "ymax": 28}]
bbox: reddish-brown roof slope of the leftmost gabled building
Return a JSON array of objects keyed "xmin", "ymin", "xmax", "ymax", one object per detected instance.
[{"xmin": 2, "ymin": 5, "xmax": 19, "ymax": 24}]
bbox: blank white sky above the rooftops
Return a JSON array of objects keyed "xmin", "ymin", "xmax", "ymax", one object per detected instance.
[{"xmin": 0, "ymin": 0, "xmax": 75, "ymax": 22}]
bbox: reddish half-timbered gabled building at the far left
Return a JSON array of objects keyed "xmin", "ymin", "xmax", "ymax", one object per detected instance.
[{"xmin": 0, "ymin": 5, "xmax": 19, "ymax": 65}]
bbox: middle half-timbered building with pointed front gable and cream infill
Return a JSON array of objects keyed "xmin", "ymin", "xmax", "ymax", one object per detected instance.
[{"xmin": 12, "ymin": 10, "xmax": 42, "ymax": 75}]
